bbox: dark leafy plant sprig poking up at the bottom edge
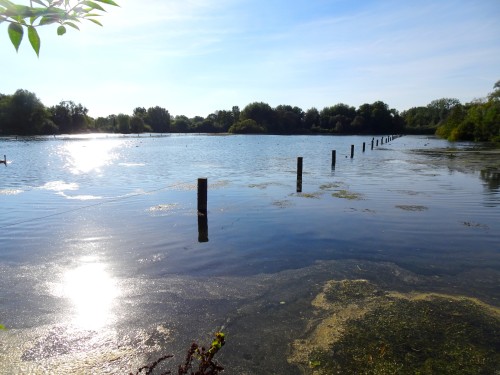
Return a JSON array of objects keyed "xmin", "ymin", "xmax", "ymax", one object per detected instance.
[{"xmin": 130, "ymin": 332, "xmax": 225, "ymax": 375}]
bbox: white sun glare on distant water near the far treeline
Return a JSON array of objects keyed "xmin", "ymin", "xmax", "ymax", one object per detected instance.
[{"xmin": 63, "ymin": 139, "xmax": 119, "ymax": 174}]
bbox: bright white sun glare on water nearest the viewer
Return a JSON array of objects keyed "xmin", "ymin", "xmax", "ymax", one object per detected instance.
[{"xmin": 56, "ymin": 258, "xmax": 119, "ymax": 330}]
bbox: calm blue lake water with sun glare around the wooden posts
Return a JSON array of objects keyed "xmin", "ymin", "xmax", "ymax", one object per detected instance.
[{"xmin": 0, "ymin": 135, "xmax": 500, "ymax": 374}]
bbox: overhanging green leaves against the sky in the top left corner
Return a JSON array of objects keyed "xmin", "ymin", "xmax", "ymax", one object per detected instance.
[{"xmin": 0, "ymin": 0, "xmax": 118, "ymax": 56}]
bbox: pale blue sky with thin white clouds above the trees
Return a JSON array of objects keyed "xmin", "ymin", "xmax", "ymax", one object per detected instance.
[{"xmin": 0, "ymin": 0, "xmax": 500, "ymax": 117}]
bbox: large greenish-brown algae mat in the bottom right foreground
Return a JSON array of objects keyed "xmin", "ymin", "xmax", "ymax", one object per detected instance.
[{"xmin": 289, "ymin": 280, "xmax": 500, "ymax": 375}]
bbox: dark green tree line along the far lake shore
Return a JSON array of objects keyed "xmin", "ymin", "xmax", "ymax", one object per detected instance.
[{"xmin": 0, "ymin": 81, "xmax": 500, "ymax": 141}]
